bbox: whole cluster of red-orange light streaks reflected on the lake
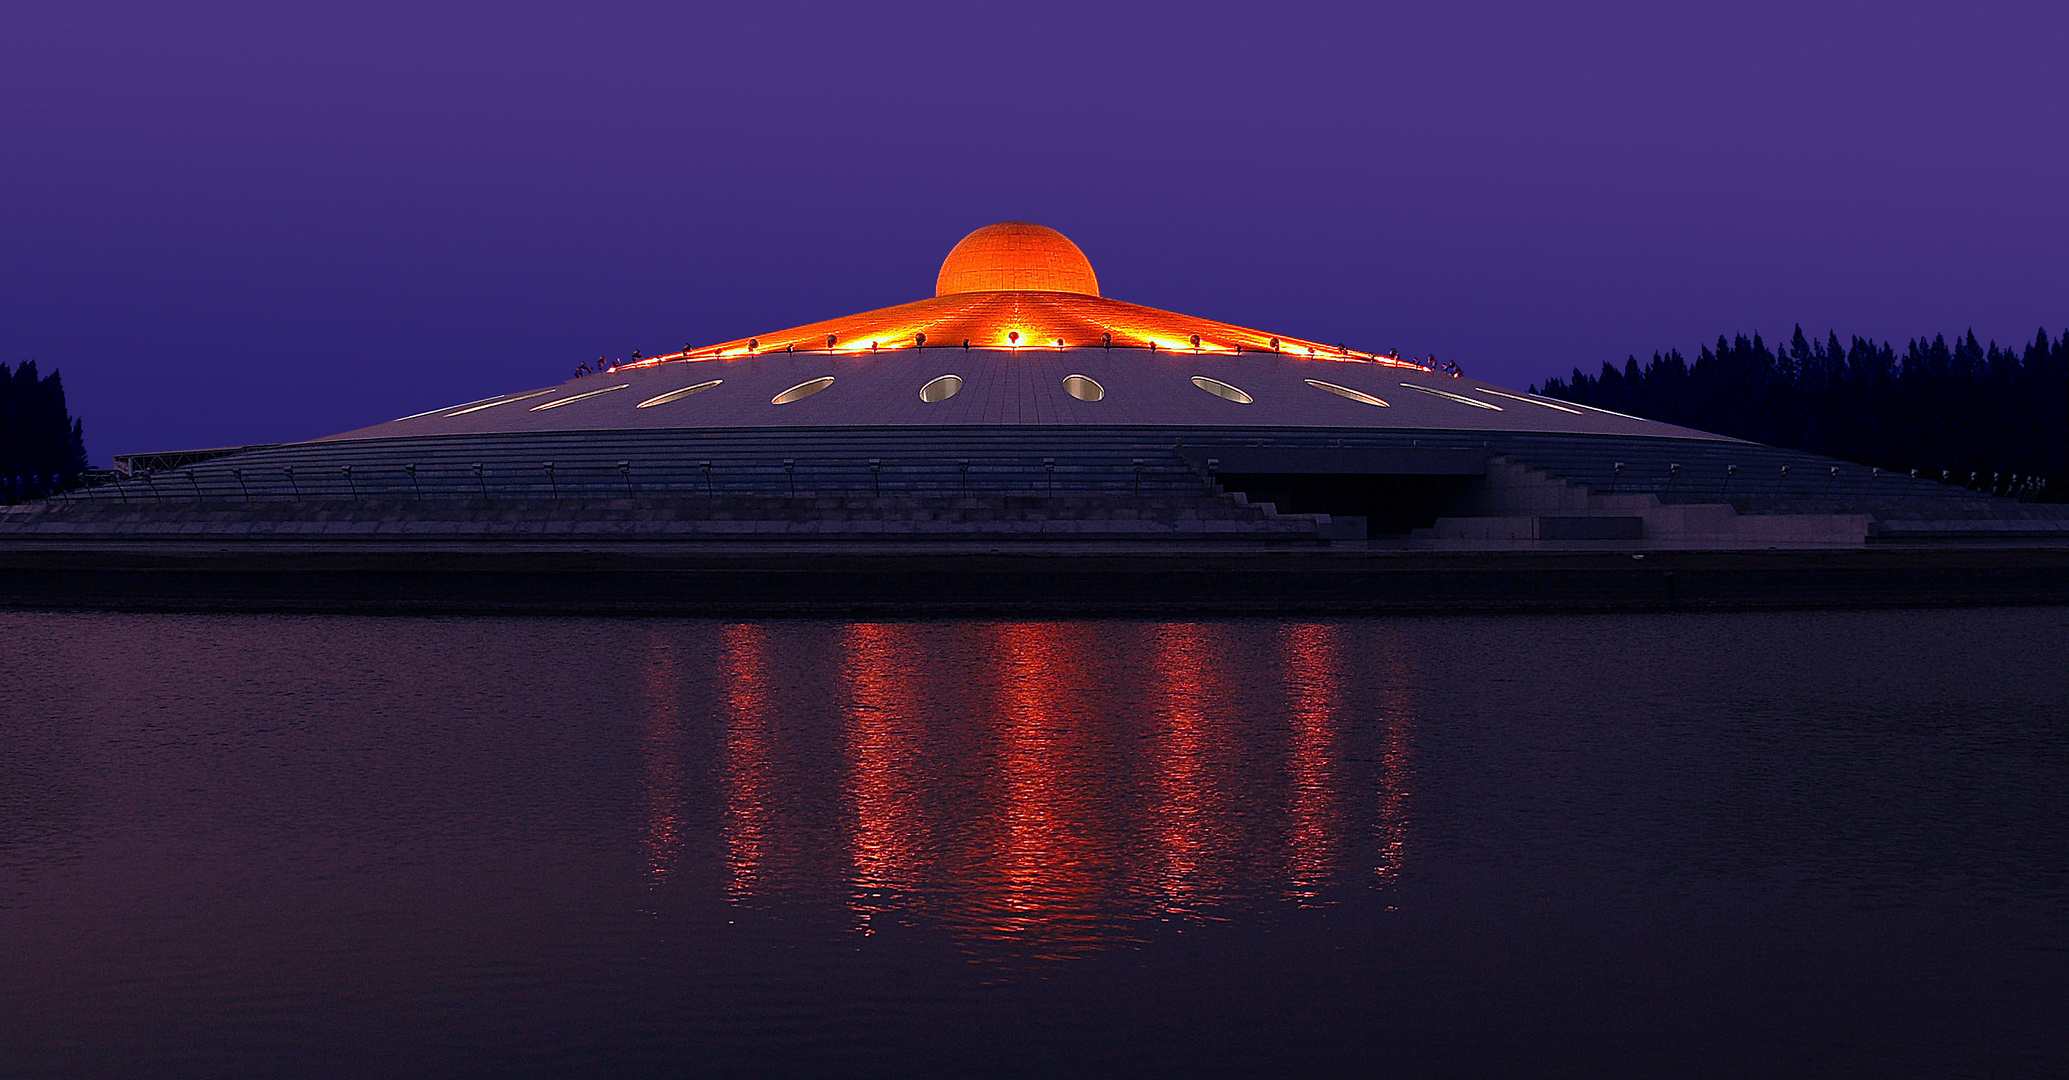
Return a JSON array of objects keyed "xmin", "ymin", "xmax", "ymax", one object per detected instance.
[{"xmin": 703, "ymin": 623, "xmax": 1415, "ymax": 960}]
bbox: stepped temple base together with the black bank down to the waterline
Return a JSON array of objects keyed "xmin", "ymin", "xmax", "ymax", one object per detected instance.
[{"xmin": 0, "ymin": 428, "xmax": 2069, "ymax": 614}]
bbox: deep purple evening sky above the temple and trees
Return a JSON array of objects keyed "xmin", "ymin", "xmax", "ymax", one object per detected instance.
[{"xmin": 0, "ymin": 0, "xmax": 2069, "ymax": 463}]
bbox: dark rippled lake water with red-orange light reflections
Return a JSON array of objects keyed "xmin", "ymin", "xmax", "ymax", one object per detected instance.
[{"xmin": 0, "ymin": 608, "xmax": 2069, "ymax": 1076}]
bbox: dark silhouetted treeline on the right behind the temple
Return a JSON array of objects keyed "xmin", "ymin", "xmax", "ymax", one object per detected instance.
[{"xmin": 1533, "ymin": 327, "xmax": 2069, "ymax": 484}]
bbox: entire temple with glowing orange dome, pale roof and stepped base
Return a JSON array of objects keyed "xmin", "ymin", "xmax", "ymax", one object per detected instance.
[{"xmin": 0, "ymin": 221, "xmax": 2069, "ymax": 604}]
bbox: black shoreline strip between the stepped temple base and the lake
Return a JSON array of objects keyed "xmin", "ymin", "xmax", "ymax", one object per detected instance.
[{"xmin": 0, "ymin": 544, "xmax": 2069, "ymax": 617}]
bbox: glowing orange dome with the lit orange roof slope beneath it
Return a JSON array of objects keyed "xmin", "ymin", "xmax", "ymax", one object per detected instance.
[{"xmin": 633, "ymin": 221, "xmax": 1415, "ymax": 368}]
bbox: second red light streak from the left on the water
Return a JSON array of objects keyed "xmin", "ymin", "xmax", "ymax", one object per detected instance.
[{"xmin": 718, "ymin": 623, "xmax": 774, "ymax": 900}]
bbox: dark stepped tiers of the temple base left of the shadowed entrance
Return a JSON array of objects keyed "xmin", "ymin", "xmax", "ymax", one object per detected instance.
[{"xmin": 0, "ymin": 428, "xmax": 1363, "ymax": 546}]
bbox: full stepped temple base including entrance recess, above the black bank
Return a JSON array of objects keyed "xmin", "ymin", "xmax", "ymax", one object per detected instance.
[{"xmin": 20, "ymin": 426, "xmax": 2069, "ymax": 550}]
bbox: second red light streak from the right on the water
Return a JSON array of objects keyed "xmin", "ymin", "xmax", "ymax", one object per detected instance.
[{"xmin": 1281, "ymin": 623, "xmax": 1343, "ymax": 902}]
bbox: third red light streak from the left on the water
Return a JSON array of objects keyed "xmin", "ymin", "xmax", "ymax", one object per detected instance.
[{"xmin": 842, "ymin": 623, "xmax": 925, "ymax": 925}]
